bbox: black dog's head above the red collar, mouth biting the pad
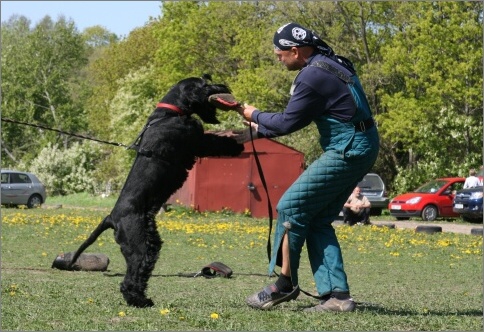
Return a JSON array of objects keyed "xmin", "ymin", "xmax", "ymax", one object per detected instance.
[{"xmin": 161, "ymin": 75, "xmax": 231, "ymax": 124}]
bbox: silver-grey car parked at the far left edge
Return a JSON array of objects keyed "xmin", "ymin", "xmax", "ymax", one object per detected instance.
[{"xmin": 1, "ymin": 169, "xmax": 47, "ymax": 208}]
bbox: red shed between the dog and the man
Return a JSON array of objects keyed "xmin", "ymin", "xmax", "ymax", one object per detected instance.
[{"xmin": 168, "ymin": 138, "xmax": 304, "ymax": 218}]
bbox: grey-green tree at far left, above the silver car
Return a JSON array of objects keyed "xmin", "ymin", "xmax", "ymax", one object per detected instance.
[{"xmin": 2, "ymin": 16, "xmax": 87, "ymax": 162}]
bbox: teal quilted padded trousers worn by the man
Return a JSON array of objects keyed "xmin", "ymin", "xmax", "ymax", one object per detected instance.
[{"xmin": 269, "ymin": 137, "xmax": 378, "ymax": 295}]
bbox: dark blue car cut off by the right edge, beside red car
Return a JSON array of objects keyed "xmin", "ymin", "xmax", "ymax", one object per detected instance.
[{"xmin": 453, "ymin": 169, "xmax": 484, "ymax": 223}]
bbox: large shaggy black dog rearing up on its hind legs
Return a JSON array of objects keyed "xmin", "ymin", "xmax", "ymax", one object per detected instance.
[{"xmin": 70, "ymin": 78, "xmax": 244, "ymax": 307}]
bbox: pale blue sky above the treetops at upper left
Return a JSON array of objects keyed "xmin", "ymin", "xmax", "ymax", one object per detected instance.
[{"xmin": 1, "ymin": 0, "xmax": 161, "ymax": 37}]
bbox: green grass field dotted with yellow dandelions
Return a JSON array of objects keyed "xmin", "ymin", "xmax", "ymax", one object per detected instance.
[{"xmin": 1, "ymin": 204, "xmax": 483, "ymax": 331}]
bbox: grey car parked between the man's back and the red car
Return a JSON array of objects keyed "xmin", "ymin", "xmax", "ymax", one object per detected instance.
[{"xmin": 358, "ymin": 173, "xmax": 388, "ymax": 216}]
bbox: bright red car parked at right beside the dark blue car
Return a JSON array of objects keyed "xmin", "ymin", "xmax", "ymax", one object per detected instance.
[{"xmin": 388, "ymin": 177, "xmax": 465, "ymax": 221}]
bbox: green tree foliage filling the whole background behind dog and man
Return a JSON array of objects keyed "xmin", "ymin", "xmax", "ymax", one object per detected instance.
[{"xmin": 2, "ymin": 1, "xmax": 483, "ymax": 197}]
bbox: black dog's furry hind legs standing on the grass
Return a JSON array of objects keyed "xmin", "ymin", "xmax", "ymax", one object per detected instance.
[{"xmin": 116, "ymin": 217, "xmax": 163, "ymax": 308}]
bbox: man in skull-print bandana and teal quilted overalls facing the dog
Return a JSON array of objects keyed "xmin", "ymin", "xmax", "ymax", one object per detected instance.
[{"xmin": 236, "ymin": 23, "xmax": 379, "ymax": 311}]
